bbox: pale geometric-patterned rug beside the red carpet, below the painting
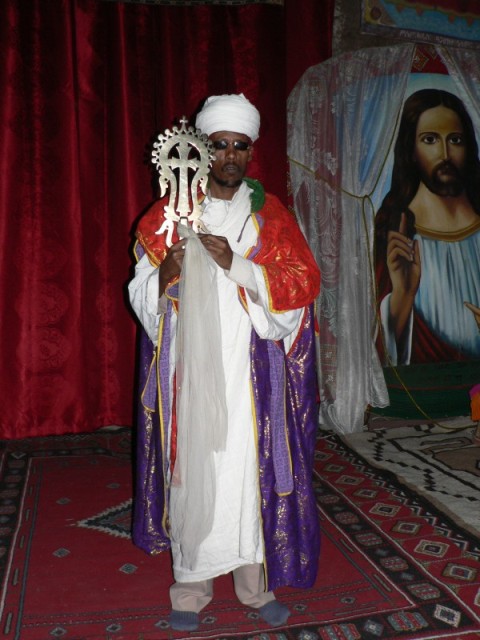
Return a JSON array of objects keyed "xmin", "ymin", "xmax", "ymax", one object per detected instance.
[{"xmin": 344, "ymin": 418, "xmax": 480, "ymax": 536}]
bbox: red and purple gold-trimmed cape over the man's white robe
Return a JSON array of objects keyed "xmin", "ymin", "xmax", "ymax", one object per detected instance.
[{"xmin": 133, "ymin": 181, "xmax": 320, "ymax": 589}]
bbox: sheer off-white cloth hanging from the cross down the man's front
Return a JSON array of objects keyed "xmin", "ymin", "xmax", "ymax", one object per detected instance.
[{"xmin": 170, "ymin": 225, "xmax": 227, "ymax": 569}]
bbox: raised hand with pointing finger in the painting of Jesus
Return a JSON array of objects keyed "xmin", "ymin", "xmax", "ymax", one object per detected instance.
[{"xmin": 387, "ymin": 213, "xmax": 421, "ymax": 341}]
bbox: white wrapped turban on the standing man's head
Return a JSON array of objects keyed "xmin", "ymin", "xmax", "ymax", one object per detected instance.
[{"xmin": 196, "ymin": 93, "xmax": 260, "ymax": 142}]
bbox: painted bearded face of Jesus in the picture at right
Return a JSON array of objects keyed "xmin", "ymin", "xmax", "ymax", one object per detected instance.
[{"xmin": 413, "ymin": 106, "xmax": 466, "ymax": 196}]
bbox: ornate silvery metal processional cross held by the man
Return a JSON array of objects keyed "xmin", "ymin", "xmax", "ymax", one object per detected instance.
[{"xmin": 152, "ymin": 116, "xmax": 215, "ymax": 247}]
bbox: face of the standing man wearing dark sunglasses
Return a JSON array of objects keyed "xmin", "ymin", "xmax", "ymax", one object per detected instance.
[{"xmin": 210, "ymin": 131, "xmax": 253, "ymax": 196}]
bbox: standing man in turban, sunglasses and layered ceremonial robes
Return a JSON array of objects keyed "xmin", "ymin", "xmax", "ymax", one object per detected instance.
[{"xmin": 129, "ymin": 94, "xmax": 320, "ymax": 631}]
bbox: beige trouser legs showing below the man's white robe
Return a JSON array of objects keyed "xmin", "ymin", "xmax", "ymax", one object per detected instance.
[{"xmin": 170, "ymin": 564, "xmax": 275, "ymax": 613}]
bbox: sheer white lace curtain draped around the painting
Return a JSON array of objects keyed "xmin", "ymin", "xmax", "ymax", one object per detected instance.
[{"xmin": 288, "ymin": 44, "xmax": 480, "ymax": 433}]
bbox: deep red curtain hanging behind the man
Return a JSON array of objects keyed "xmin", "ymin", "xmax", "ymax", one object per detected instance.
[{"xmin": 0, "ymin": 0, "xmax": 333, "ymax": 438}]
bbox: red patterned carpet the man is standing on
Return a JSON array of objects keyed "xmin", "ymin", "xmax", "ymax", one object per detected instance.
[{"xmin": 0, "ymin": 429, "xmax": 480, "ymax": 640}]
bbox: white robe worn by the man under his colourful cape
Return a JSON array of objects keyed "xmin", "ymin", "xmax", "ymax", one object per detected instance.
[{"xmin": 125, "ymin": 183, "xmax": 303, "ymax": 582}]
